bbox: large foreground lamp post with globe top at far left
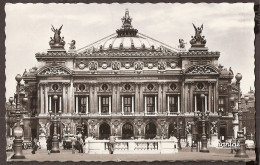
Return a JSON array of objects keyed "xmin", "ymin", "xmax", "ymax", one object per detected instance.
[{"xmin": 9, "ymin": 74, "xmax": 27, "ymax": 159}]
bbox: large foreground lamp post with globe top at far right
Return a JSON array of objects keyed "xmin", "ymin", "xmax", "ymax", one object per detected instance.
[{"xmin": 234, "ymin": 73, "xmax": 248, "ymax": 158}]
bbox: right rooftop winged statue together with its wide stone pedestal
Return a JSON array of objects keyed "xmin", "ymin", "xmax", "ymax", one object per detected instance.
[{"xmin": 189, "ymin": 23, "xmax": 208, "ymax": 51}]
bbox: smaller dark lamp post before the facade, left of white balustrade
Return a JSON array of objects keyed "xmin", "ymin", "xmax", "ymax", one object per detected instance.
[{"xmin": 49, "ymin": 95, "xmax": 61, "ymax": 153}]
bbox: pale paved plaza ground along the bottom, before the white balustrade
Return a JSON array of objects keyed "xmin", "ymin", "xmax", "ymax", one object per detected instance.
[{"xmin": 7, "ymin": 148, "xmax": 255, "ymax": 161}]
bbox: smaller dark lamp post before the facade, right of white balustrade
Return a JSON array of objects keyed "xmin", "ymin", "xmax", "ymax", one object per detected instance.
[{"xmin": 198, "ymin": 94, "xmax": 209, "ymax": 153}]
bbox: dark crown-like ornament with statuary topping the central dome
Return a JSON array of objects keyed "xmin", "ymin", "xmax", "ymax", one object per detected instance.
[{"xmin": 116, "ymin": 9, "xmax": 138, "ymax": 37}]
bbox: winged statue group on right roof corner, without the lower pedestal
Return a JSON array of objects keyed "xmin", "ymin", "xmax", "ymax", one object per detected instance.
[{"xmin": 190, "ymin": 24, "xmax": 206, "ymax": 47}]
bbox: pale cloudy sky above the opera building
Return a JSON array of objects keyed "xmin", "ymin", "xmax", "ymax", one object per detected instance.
[{"xmin": 5, "ymin": 3, "xmax": 255, "ymax": 99}]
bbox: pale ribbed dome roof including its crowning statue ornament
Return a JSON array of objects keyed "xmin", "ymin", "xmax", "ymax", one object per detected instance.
[{"xmin": 78, "ymin": 10, "xmax": 179, "ymax": 53}]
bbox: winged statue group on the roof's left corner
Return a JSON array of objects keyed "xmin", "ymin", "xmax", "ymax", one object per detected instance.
[{"xmin": 49, "ymin": 25, "xmax": 65, "ymax": 49}]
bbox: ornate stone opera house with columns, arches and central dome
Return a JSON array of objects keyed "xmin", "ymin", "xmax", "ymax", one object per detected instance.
[{"xmin": 17, "ymin": 11, "xmax": 237, "ymax": 140}]
